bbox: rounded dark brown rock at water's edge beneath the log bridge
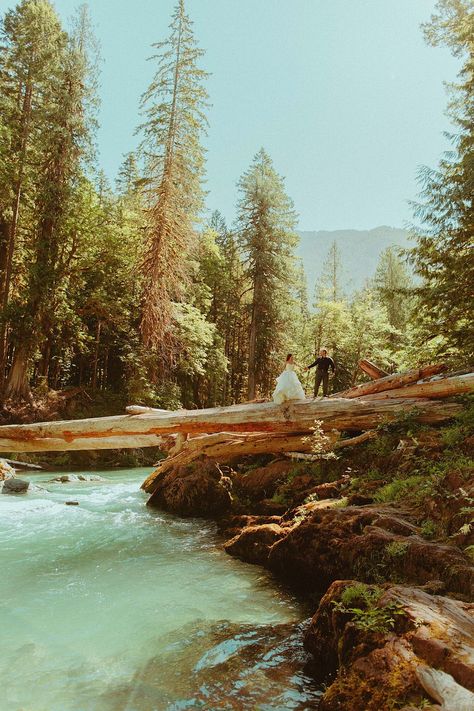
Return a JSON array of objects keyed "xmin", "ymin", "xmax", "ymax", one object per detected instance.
[{"xmin": 148, "ymin": 459, "xmax": 232, "ymax": 518}]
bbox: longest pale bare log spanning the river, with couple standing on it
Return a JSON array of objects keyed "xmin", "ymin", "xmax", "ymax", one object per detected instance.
[{"xmin": 0, "ymin": 394, "xmax": 464, "ymax": 452}]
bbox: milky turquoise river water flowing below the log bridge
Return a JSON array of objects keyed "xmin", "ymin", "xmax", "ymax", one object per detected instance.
[{"xmin": 0, "ymin": 469, "xmax": 319, "ymax": 711}]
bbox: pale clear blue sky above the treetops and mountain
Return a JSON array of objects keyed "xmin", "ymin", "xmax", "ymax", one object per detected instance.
[{"xmin": 0, "ymin": 0, "xmax": 458, "ymax": 230}]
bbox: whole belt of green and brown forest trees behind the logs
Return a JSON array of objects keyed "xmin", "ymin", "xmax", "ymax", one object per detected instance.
[{"xmin": 0, "ymin": 0, "xmax": 474, "ymax": 408}]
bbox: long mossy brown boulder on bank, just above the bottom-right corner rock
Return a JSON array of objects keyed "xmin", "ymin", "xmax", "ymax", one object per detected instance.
[{"xmin": 268, "ymin": 506, "xmax": 474, "ymax": 598}]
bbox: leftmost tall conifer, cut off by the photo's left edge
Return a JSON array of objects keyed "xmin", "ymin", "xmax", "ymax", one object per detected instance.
[{"xmin": 0, "ymin": 0, "xmax": 65, "ymax": 387}]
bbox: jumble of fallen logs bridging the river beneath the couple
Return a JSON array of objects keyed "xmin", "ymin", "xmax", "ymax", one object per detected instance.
[{"xmin": 0, "ymin": 361, "xmax": 474, "ymax": 493}]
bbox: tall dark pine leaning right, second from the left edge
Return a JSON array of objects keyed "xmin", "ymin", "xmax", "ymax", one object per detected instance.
[{"xmin": 5, "ymin": 2, "xmax": 98, "ymax": 398}]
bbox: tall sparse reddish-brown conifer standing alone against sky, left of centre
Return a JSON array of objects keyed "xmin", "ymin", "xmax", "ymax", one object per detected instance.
[{"xmin": 140, "ymin": 0, "xmax": 207, "ymax": 373}]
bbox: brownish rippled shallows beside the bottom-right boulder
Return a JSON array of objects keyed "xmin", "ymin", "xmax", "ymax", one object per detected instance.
[{"xmin": 95, "ymin": 622, "xmax": 322, "ymax": 711}]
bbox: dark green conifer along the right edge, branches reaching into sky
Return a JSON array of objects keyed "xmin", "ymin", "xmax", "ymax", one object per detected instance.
[{"xmin": 411, "ymin": 0, "xmax": 474, "ymax": 361}]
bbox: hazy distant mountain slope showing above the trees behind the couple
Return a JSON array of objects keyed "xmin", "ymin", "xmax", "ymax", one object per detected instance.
[{"xmin": 297, "ymin": 226, "xmax": 410, "ymax": 300}]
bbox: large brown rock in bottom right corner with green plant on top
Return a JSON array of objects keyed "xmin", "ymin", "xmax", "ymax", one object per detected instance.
[{"xmin": 305, "ymin": 581, "xmax": 474, "ymax": 711}]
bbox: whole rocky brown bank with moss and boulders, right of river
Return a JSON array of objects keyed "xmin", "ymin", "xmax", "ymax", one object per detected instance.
[{"xmin": 150, "ymin": 403, "xmax": 474, "ymax": 711}]
